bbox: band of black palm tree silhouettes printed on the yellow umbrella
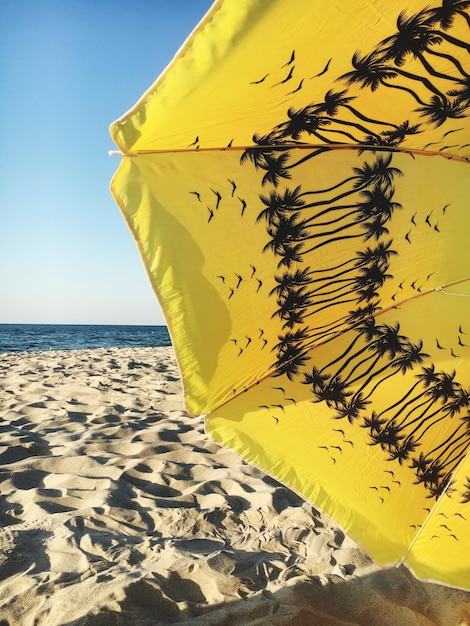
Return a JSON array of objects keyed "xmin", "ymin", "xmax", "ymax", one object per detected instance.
[{"xmin": 241, "ymin": 0, "xmax": 470, "ymax": 502}]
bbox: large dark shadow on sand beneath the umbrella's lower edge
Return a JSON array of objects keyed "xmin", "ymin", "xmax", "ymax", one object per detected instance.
[{"xmin": 64, "ymin": 567, "xmax": 470, "ymax": 626}]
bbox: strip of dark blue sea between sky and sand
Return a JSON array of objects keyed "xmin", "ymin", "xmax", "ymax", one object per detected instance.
[{"xmin": 0, "ymin": 324, "xmax": 171, "ymax": 352}]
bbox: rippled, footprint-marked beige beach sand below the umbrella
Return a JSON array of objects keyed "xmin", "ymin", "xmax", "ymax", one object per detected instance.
[{"xmin": 0, "ymin": 348, "xmax": 470, "ymax": 626}]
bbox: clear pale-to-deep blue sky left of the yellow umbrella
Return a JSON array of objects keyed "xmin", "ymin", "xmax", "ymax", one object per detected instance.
[{"xmin": 0, "ymin": 0, "xmax": 212, "ymax": 324}]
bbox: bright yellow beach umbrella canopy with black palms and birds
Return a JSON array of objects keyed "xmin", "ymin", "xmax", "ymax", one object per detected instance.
[{"xmin": 111, "ymin": 0, "xmax": 470, "ymax": 588}]
